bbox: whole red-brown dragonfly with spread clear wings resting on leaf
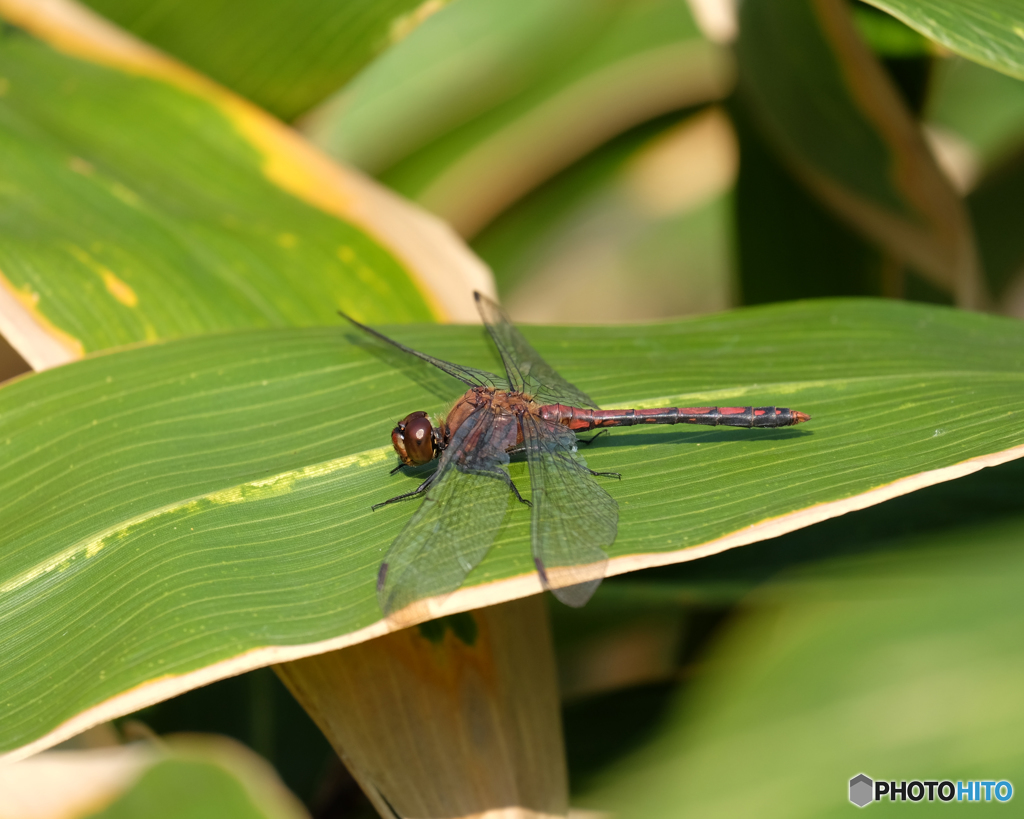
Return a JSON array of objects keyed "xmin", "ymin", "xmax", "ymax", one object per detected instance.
[{"xmin": 341, "ymin": 293, "xmax": 810, "ymax": 616}]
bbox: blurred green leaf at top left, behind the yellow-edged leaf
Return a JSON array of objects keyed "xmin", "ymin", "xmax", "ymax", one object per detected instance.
[{"xmin": 79, "ymin": 0, "xmax": 428, "ymax": 120}]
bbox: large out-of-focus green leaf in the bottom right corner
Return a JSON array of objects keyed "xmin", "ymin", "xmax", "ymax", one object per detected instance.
[{"xmin": 575, "ymin": 514, "xmax": 1024, "ymax": 819}]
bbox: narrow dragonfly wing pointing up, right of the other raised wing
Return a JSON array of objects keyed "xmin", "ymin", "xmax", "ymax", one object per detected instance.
[{"xmin": 473, "ymin": 293, "xmax": 597, "ymax": 407}]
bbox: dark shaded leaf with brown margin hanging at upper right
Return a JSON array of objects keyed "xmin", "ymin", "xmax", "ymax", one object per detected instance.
[{"xmin": 737, "ymin": 0, "xmax": 985, "ymax": 306}]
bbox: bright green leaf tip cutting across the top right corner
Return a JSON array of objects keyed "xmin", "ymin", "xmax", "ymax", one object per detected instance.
[{"xmin": 866, "ymin": 0, "xmax": 1024, "ymax": 80}]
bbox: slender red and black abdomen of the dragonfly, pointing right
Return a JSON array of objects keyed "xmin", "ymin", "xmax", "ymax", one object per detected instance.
[{"xmin": 538, "ymin": 403, "xmax": 810, "ymax": 432}]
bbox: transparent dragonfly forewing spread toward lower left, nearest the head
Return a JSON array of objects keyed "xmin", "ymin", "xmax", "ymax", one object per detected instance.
[{"xmin": 377, "ymin": 408, "xmax": 515, "ymax": 615}]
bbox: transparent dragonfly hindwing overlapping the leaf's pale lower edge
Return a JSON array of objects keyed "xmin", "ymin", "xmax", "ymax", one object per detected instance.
[{"xmin": 522, "ymin": 415, "xmax": 618, "ymax": 606}]
